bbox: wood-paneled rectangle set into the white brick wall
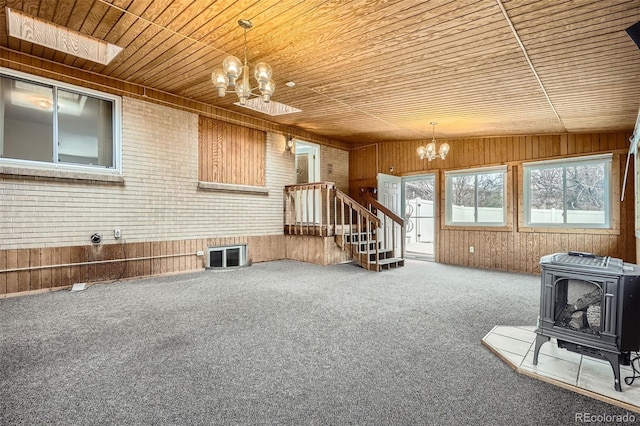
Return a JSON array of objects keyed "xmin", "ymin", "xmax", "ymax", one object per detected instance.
[{"xmin": 198, "ymin": 116, "xmax": 266, "ymax": 186}]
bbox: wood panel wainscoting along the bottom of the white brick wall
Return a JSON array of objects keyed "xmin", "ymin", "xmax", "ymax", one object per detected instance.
[{"xmin": 0, "ymin": 235, "xmax": 286, "ymax": 297}]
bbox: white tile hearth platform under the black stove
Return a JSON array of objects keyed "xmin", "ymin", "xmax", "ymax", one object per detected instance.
[{"xmin": 482, "ymin": 325, "xmax": 640, "ymax": 413}]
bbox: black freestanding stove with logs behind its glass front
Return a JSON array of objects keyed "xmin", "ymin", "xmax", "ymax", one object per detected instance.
[{"xmin": 533, "ymin": 252, "xmax": 640, "ymax": 391}]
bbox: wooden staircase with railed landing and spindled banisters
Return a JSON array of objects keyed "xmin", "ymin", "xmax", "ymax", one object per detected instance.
[{"xmin": 284, "ymin": 182, "xmax": 404, "ymax": 271}]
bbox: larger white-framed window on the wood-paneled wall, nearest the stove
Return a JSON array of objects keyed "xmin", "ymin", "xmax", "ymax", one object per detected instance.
[{"xmin": 523, "ymin": 155, "xmax": 611, "ymax": 228}]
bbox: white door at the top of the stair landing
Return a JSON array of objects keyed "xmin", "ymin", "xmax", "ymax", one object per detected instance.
[{"xmin": 295, "ymin": 140, "xmax": 321, "ymax": 223}]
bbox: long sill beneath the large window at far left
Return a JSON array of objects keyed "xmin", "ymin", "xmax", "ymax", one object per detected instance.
[{"xmin": 0, "ymin": 165, "xmax": 124, "ymax": 184}]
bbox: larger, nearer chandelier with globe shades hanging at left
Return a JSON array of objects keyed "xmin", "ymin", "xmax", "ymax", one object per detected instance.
[{"xmin": 211, "ymin": 19, "xmax": 276, "ymax": 105}]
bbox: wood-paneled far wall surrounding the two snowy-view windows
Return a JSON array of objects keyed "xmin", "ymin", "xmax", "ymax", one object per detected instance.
[{"xmin": 349, "ymin": 132, "xmax": 636, "ymax": 273}]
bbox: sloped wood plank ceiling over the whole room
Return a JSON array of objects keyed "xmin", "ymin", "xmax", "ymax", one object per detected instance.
[{"xmin": 0, "ymin": 0, "xmax": 640, "ymax": 143}]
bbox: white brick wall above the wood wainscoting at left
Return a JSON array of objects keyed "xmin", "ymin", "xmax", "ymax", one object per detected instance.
[{"xmin": 0, "ymin": 98, "xmax": 312, "ymax": 249}]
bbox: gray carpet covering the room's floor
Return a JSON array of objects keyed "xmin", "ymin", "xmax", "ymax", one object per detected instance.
[{"xmin": 0, "ymin": 261, "xmax": 640, "ymax": 425}]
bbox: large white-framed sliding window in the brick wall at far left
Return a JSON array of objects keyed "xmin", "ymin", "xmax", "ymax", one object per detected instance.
[{"xmin": 0, "ymin": 70, "xmax": 120, "ymax": 170}]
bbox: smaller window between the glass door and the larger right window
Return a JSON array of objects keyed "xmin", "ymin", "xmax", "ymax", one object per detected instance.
[{"xmin": 445, "ymin": 167, "xmax": 507, "ymax": 226}]
